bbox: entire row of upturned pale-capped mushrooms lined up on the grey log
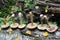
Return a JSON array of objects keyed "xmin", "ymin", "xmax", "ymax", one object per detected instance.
[{"xmin": 1, "ymin": 12, "xmax": 58, "ymax": 32}]
